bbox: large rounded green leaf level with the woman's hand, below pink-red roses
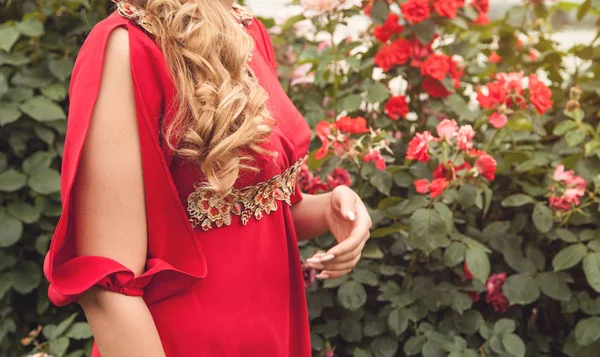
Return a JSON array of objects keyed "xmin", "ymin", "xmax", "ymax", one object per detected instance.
[{"xmin": 409, "ymin": 208, "xmax": 449, "ymax": 254}]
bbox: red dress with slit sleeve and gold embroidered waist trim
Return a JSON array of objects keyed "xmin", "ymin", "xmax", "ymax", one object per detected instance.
[{"xmin": 44, "ymin": 8, "xmax": 311, "ymax": 357}]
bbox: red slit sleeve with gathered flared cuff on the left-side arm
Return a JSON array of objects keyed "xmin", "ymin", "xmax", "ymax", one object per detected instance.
[{"xmin": 44, "ymin": 13, "xmax": 206, "ymax": 306}]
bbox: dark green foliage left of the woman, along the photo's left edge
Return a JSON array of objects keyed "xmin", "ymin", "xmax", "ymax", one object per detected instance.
[{"xmin": 0, "ymin": 0, "xmax": 108, "ymax": 357}]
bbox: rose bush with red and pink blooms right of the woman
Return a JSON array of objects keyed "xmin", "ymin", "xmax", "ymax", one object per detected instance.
[{"xmin": 272, "ymin": 0, "xmax": 600, "ymax": 357}]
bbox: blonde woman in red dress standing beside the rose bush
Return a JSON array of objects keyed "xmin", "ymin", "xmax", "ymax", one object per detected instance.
[{"xmin": 44, "ymin": 0, "xmax": 371, "ymax": 357}]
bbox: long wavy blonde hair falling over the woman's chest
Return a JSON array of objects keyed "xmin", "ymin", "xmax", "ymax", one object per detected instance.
[{"xmin": 128, "ymin": 0, "xmax": 273, "ymax": 194}]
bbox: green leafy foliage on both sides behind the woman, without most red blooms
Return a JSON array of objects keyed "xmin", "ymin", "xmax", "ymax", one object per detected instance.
[{"xmin": 0, "ymin": 0, "xmax": 600, "ymax": 357}]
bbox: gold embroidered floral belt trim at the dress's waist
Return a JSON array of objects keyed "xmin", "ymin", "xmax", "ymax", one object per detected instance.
[{"xmin": 187, "ymin": 158, "xmax": 304, "ymax": 231}]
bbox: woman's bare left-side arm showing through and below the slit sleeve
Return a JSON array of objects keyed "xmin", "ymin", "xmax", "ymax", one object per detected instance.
[{"xmin": 73, "ymin": 29, "xmax": 165, "ymax": 357}]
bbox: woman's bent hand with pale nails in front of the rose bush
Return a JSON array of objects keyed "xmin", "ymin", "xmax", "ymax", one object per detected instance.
[{"xmin": 306, "ymin": 186, "xmax": 372, "ymax": 279}]
